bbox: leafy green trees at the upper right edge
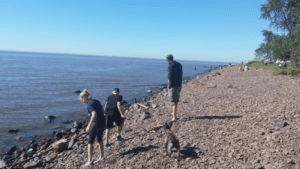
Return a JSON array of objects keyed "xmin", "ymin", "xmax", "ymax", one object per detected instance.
[{"xmin": 255, "ymin": 0, "xmax": 300, "ymax": 66}]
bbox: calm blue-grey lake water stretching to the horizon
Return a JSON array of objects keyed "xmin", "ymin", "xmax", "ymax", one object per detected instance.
[{"xmin": 0, "ymin": 52, "xmax": 224, "ymax": 151}]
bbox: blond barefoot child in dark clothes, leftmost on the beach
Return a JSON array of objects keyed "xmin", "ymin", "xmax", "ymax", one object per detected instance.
[{"xmin": 79, "ymin": 89, "xmax": 105, "ymax": 167}]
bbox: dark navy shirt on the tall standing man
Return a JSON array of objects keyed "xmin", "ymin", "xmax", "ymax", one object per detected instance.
[{"xmin": 168, "ymin": 61, "xmax": 182, "ymax": 87}]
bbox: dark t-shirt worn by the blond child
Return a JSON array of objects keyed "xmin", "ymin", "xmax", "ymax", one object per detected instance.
[{"xmin": 87, "ymin": 99, "xmax": 105, "ymax": 126}]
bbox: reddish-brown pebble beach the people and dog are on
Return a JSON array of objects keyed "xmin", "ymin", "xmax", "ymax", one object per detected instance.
[{"xmin": 0, "ymin": 64, "xmax": 300, "ymax": 169}]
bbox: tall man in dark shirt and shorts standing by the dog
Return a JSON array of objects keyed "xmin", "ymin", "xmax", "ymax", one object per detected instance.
[{"xmin": 167, "ymin": 54, "xmax": 182, "ymax": 122}]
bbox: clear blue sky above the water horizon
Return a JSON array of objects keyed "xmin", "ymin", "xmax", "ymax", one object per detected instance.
[{"xmin": 0, "ymin": 0, "xmax": 284, "ymax": 62}]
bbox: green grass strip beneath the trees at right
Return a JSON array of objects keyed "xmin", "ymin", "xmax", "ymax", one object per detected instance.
[{"xmin": 250, "ymin": 61, "xmax": 300, "ymax": 75}]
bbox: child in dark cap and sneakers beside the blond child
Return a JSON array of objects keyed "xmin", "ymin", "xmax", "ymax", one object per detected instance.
[{"xmin": 104, "ymin": 88, "xmax": 125, "ymax": 147}]
